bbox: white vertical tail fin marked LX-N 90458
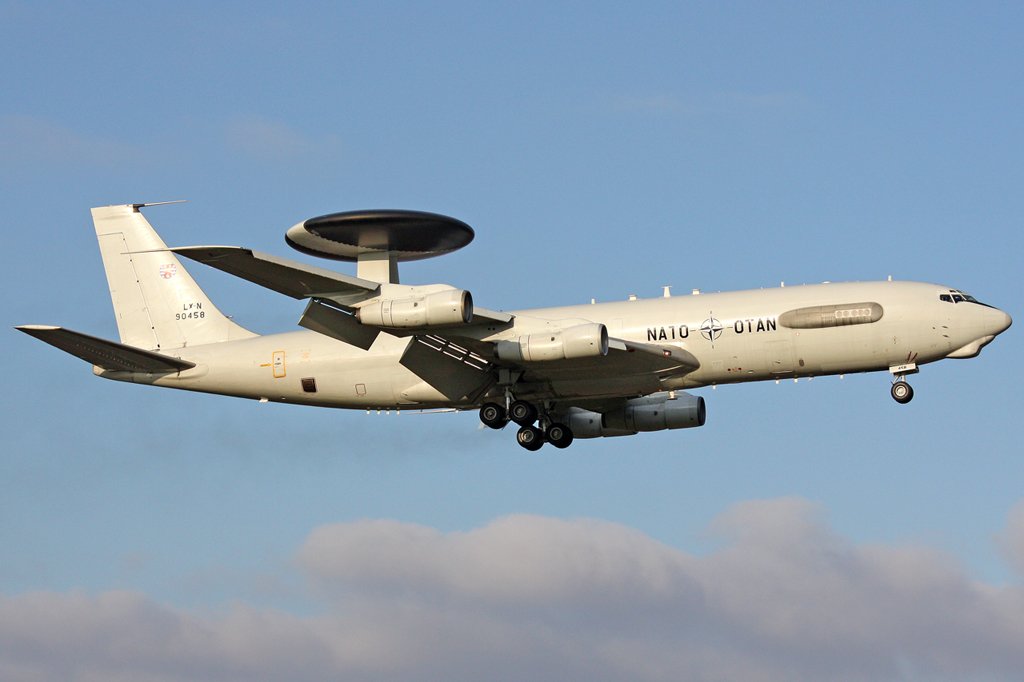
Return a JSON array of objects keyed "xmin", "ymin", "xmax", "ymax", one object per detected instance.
[{"xmin": 92, "ymin": 204, "xmax": 256, "ymax": 350}]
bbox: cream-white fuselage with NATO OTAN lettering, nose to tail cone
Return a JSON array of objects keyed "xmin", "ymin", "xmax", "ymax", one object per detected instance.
[{"xmin": 96, "ymin": 282, "xmax": 1010, "ymax": 409}]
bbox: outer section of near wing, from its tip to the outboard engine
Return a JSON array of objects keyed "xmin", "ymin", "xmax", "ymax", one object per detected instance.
[{"xmin": 171, "ymin": 246, "xmax": 380, "ymax": 305}]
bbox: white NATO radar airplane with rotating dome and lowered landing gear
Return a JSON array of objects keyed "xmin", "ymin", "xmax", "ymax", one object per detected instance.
[{"xmin": 15, "ymin": 202, "xmax": 1012, "ymax": 451}]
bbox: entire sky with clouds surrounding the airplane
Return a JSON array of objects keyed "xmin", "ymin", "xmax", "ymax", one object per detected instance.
[{"xmin": 0, "ymin": 1, "xmax": 1024, "ymax": 680}]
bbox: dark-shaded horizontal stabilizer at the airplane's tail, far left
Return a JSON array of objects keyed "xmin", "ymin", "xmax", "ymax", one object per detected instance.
[{"xmin": 14, "ymin": 325, "xmax": 196, "ymax": 374}]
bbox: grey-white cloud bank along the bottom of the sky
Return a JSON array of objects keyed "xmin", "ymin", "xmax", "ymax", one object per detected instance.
[{"xmin": 0, "ymin": 499, "xmax": 1024, "ymax": 682}]
